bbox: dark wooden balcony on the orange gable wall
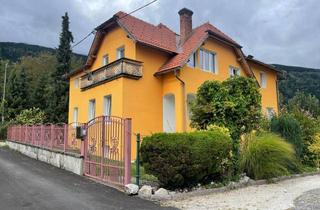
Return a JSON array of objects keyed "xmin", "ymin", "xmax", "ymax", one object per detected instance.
[{"xmin": 80, "ymin": 58, "xmax": 142, "ymax": 90}]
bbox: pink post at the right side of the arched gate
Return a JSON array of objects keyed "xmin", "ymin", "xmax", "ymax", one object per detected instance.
[{"xmin": 124, "ymin": 118, "xmax": 131, "ymax": 185}]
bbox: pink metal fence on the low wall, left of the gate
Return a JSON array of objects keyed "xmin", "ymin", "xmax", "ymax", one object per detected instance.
[{"xmin": 7, "ymin": 123, "xmax": 84, "ymax": 154}]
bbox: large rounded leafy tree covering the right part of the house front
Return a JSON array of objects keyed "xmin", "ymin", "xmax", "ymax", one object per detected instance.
[{"xmin": 191, "ymin": 77, "xmax": 261, "ymax": 173}]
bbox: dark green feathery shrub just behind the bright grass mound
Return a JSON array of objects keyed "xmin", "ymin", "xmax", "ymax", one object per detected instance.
[{"xmin": 271, "ymin": 112, "xmax": 305, "ymax": 157}]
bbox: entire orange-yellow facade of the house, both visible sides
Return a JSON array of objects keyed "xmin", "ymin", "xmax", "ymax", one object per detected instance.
[{"xmin": 68, "ymin": 26, "xmax": 278, "ymax": 157}]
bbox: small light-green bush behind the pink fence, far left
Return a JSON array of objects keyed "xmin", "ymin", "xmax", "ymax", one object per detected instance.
[{"xmin": 15, "ymin": 108, "xmax": 45, "ymax": 125}]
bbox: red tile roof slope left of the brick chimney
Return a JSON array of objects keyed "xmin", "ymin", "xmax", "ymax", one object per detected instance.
[{"xmin": 115, "ymin": 12, "xmax": 177, "ymax": 52}]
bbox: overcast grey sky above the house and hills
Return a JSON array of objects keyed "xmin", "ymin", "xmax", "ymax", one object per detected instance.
[{"xmin": 0, "ymin": 0, "xmax": 320, "ymax": 68}]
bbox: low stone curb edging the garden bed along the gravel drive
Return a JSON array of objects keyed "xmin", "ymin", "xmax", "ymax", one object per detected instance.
[{"xmin": 148, "ymin": 171, "xmax": 320, "ymax": 201}]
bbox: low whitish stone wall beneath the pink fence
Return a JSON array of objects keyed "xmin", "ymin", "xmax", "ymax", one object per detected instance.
[{"xmin": 7, "ymin": 140, "xmax": 83, "ymax": 175}]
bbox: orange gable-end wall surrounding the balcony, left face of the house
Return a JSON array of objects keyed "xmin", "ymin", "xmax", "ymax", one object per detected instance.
[{"xmin": 68, "ymin": 27, "xmax": 136, "ymax": 123}]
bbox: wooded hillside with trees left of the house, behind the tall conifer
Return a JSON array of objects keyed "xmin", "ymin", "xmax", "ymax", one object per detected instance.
[{"xmin": 0, "ymin": 42, "xmax": 86, "ymax": 121}]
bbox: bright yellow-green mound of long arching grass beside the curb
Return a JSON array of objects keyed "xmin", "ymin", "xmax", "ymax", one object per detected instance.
[{"xmin": 240, "ymin": 133, "xmax": 300, "ymax": 179}]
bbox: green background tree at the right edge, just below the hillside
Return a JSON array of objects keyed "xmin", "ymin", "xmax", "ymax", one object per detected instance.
[{"xmin": 288, "ymin": 91, "xmax": 320, "ymax": 117}]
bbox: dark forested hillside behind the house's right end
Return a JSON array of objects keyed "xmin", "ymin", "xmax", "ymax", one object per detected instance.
[{"xmin": 273, "ymin": 64, "xmax": 320, "ymax": 102}]
